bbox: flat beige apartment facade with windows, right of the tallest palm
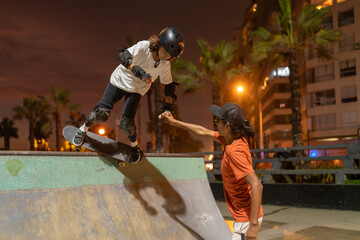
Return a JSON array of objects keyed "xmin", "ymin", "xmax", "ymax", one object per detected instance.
[{"xmin": 303, "ymin": 0, "xmax": 360, "ymax": 145}]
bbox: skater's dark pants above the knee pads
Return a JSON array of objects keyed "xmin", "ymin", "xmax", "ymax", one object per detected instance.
[{"xmin": 85, "ymin": 82, "xmax": 141, "ymax": 127}]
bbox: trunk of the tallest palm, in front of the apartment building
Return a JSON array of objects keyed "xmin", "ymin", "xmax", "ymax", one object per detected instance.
[{"xmin": 289, "ymin": 50, "xmax": 302, "ymax": 147}]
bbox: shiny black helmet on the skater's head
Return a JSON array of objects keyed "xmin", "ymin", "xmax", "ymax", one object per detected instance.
[{"xmin": 159, "ymin": 27, "xmax": 184, "ymax": 58}]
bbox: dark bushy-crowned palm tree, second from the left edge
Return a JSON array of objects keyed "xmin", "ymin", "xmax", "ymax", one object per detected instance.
[{"xmin": 13, "ymin": 96, "xmax": 50, "ymax": 150}]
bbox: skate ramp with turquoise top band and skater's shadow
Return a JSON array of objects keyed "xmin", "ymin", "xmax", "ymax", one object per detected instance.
[{"xmin": 0, "ymin": 151, "xmax": 231, "ymax": 240}]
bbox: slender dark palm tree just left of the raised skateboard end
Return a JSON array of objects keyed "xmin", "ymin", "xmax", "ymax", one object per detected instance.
[{"xmin": 51, "ymin": 87, "xmax": 78, "ymax": 151}]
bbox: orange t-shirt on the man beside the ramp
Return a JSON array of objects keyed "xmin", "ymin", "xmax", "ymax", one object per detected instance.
[{"xmin": 214, "ymin": 132, "xmax": 263, "ymax": 222}]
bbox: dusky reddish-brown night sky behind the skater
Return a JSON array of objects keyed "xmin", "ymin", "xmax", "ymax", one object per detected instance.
[{"xmin": 0, "ymin": 0, "xmax": 251, "ymax": 151}]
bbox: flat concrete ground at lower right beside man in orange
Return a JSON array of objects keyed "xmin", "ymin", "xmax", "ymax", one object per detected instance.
[{"xmin": 217, "ymin": 201, "xmax": 360, "ymax": 240}]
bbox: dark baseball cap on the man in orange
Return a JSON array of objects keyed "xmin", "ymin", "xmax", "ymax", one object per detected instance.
[{"xmin": 210, "ymin": 102, "xmax": 247, "ymax": 128}]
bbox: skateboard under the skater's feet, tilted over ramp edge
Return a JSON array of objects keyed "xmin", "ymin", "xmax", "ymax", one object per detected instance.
[{"xmin": 63, "ymin": 126, "xmax": 144, "ymax": 166}]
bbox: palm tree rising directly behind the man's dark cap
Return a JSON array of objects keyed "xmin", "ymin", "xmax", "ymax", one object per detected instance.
[{"xmin": 197, "ymin": 39, "xmax": 239, "ymax": 151}]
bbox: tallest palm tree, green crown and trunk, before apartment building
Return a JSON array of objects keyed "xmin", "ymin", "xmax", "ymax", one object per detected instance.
[{"xmin": 251, "ymin": 0, "xmax": 340, "ymax": 146}]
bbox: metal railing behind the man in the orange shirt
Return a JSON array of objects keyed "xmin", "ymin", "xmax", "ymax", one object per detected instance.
[{"xmin": 201, "ymin": 144, "xmax": 360, "ymax": 184}]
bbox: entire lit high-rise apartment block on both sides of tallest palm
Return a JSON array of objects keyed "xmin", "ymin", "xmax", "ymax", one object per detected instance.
[{"xmin": 235, "ymin": 0, "xmax": 360, "ymax": 148}]
